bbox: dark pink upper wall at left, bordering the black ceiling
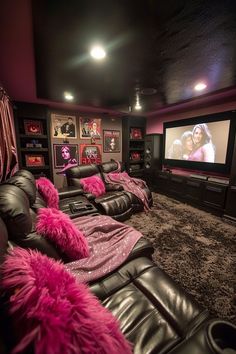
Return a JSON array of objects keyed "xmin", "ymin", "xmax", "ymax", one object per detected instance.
[{"xmin": 0, "ymin": 0, "xmax": 120, "ymax": 115}]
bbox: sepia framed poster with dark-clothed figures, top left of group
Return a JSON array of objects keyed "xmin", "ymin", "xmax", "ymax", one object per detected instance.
[{"xmin": 51, "ymin": 113, "xmax": 77, "ymax": 140}]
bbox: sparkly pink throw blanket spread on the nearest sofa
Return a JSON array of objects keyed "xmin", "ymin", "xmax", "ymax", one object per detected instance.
[{"xmin": 65, "ymin": 215, "xmax": 142, "ymax": 282}]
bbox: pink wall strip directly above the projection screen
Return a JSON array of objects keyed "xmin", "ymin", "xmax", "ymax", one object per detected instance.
[{"xmin": 147, "ymin": 89, "xmax": 236, "ymax": 134}]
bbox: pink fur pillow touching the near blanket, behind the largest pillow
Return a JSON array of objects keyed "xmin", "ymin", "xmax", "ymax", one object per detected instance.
[{"xmin": 36, "ymin": 208, "xmax": 89, "ymax": 261}]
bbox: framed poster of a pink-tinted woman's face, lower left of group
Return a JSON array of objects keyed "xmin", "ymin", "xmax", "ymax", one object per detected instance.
[{"xmin": 53, "ymin": 144, "xmax": 78, "ymax": 171}]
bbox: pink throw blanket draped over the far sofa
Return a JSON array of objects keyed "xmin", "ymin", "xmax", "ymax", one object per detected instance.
[{"xmin": 105, "ymin": 161, "xmax": 150, "ymax": 211}]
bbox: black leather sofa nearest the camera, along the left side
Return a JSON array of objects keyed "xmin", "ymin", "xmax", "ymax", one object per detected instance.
[{"xmin": 0, "ymin": 171, "xmax": 236, "ymax": 354}]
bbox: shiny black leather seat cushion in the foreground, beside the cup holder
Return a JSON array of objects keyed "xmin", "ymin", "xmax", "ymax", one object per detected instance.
[{"xmin": 91, "ymin": 257, "xmax": 208, "ymax": 354}]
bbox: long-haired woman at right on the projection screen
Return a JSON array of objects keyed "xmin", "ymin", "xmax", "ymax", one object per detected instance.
[{"xmin": 188, "ymin": 123, "xmax": 215, "ymax": 162}]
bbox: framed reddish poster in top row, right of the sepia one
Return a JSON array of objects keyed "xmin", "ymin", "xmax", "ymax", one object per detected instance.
[{"xmin": 79, "ymin": 117, "xmax": 101, "ymax": 139}]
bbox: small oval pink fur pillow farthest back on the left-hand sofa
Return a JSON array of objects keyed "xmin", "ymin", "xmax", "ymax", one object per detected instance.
[{"xmin": 36, "ymin": 177, "xmax": 59, "ymax": 209}]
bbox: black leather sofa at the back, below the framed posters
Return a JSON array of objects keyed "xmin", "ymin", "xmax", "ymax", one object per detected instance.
[{"xmin": 64, "ymin": 160, "xmax": 152, "ymax": 221}]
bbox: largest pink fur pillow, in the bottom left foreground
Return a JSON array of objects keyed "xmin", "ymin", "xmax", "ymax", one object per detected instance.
[{"xmin": 2, "ymin": 247, "xmax": 132, "ymax": 354}]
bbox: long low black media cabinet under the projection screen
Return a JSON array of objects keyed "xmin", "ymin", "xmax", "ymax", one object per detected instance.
[{"xmin": 154, "ymin": 171, "xmax": 229, "ymax": 215}]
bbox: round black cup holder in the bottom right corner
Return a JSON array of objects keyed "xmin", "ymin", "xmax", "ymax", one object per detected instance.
[{"xmin": 207, "ymin": 320, "xmax": 236, "ymax": 354}]
